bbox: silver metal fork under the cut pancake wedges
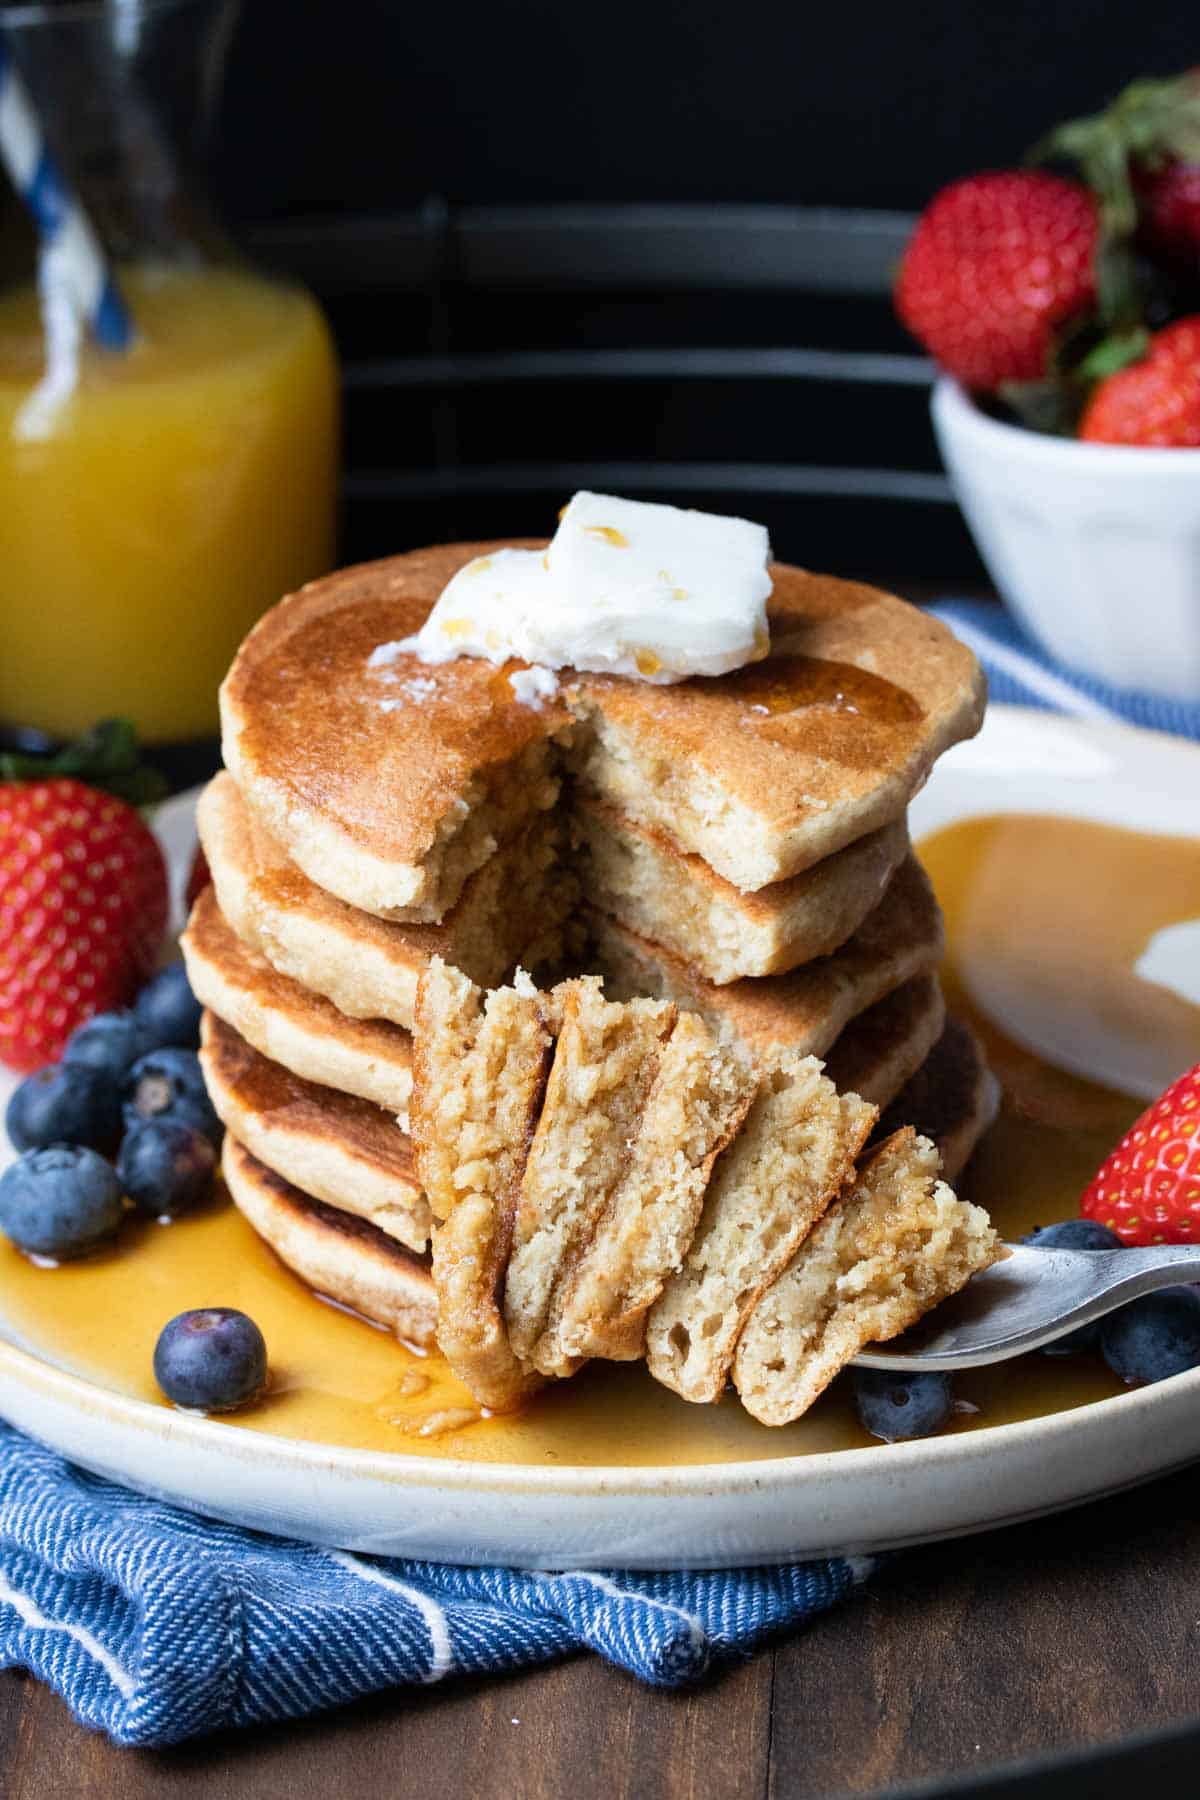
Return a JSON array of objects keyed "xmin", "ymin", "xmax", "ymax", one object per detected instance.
[{"xmin": 855, "ymin": 1244, "xmax": 1200, "ymax": 1372}]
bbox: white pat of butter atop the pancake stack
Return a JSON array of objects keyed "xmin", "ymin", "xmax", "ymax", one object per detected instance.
[{"xmin": 390, "ymin": 493, "xmax": 772, "ymax": 682}]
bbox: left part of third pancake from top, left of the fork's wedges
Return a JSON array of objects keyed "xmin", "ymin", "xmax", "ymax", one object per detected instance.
[{"xmin": 180, "ymin": 887, "xmax": 412, "ymax": 1116}]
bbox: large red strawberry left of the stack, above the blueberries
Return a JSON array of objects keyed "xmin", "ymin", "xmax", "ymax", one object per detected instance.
[{"xmin": 0, "ymin": 776, "xmax": 167, "ymax": 1069}]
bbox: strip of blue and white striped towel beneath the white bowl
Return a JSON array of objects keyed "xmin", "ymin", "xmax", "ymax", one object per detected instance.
[{"xmin": 930, "ymin": 599, "xmax": 1200, "ymax": 738}]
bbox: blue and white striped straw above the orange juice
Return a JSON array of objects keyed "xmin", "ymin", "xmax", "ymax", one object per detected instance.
[{"xmin": 0, "ymin": 34, "xmax": 133, "ymax": 349}]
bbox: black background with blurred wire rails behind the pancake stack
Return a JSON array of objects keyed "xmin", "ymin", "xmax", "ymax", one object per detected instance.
[{"xmin": 214, "ymin": 0, "xmax": 1200, "ymax": 589}]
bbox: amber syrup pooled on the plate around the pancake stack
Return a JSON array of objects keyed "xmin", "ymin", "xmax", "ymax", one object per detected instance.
[{"xmin": 0, "ymin": 815, "xmax": 1200, "ymax": 1467}]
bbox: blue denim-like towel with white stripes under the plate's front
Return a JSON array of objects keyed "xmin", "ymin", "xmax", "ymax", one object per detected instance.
[{"xmin": 0, "ymin": 1426, "xmax": 871, "ymax": 1744}]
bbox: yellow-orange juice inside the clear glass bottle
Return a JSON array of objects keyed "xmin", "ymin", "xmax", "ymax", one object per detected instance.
[{"xmin": 0, "ymin": 266, "xmax": 338, "ymax": 742}]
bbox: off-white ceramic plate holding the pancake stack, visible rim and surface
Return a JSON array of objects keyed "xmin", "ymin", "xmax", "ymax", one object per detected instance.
[{"xmin": 0, "ymin": 707, "xmax": 1200, "ymax": 1568}]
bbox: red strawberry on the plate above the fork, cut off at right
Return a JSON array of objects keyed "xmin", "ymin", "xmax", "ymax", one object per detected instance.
[{"xmin": 1079, "ymin": 1062, "xmax": 1200, "ymax": 1244}]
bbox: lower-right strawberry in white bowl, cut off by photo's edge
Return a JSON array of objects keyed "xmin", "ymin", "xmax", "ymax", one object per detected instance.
[{"xmin": 1079, "ymin": 313, "xmax": 1200, "ymax": 448}]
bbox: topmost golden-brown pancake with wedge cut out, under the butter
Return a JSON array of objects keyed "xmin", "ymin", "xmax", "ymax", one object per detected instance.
[{"xmin": 221, "ymin": 544, "xmax": 984, "ymax": 922}]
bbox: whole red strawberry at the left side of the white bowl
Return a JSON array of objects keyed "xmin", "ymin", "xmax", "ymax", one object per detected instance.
[{"xmin": 896, "ymin": 171, "xmax": 1097, "ymax": 391}]
